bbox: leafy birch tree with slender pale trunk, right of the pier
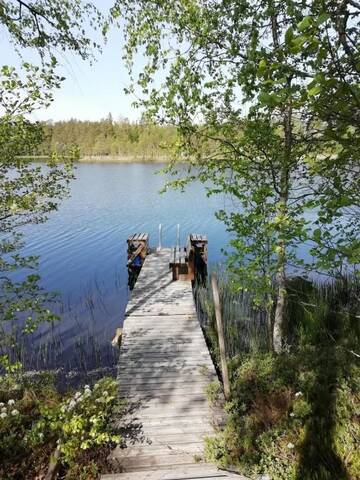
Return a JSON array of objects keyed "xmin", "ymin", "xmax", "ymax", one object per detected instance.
[{"xmin": 117, "ymin": 0, "xmax": 360, "ymax": 351}]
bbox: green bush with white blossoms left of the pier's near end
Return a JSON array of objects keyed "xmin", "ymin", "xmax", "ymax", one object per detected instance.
[{"xmin": 0, "ymin": 375, "xmax": 122, "ymax": 479}]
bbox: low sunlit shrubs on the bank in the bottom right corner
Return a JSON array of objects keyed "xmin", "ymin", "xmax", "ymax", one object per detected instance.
[{"xmin": 206, "ymin": 348, "xmax": 360, "ymax": 480}]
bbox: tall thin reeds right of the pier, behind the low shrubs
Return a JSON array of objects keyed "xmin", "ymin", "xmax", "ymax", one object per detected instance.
[{"xmin": 194, "ymin": 266, "xmax": 360, "ymax": 358}]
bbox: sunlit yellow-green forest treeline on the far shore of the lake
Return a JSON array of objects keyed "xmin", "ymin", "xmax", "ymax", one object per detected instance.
[{"xmin": 34, "ymin": 114, "xmax": 175, "ymax": 162}]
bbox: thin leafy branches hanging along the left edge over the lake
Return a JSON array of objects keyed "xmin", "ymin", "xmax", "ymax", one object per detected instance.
[{"xmin": 0, "ymin": 0, "xmax": 107, "ymax": 365}]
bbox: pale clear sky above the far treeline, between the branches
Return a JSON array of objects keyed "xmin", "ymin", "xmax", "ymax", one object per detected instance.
[{"xmin": 0, "ymin": 0, "xmax": 146, "ymax": 121}]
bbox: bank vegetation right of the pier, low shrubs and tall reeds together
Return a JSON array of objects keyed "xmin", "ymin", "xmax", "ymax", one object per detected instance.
[{"xmin": 196, "ymin": 268, "xmax": 360, "ymax": 480}]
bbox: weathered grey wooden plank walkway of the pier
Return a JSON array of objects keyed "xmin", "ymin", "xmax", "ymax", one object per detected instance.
[{"xmin": 102, "ymin": 248, "xmax": 244, "ymax": 480}]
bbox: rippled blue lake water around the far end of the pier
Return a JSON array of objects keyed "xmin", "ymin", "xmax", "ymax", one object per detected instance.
[{"xmin": 20, "ymin": 164, "xmax": 229, "ymax": 368}]
